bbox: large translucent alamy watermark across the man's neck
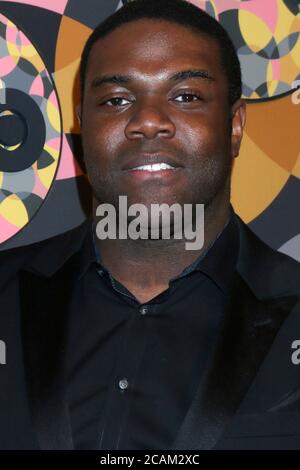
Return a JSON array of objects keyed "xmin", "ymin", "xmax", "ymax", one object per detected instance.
[{"xmin": 96, "ymin": 196, "xmax": 204, "ymax": 250}]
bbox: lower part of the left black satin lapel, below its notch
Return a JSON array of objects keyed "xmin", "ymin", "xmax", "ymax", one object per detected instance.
[{"xmin": 20, "ymin": 263, "xmax": 77, "ymax": 450}]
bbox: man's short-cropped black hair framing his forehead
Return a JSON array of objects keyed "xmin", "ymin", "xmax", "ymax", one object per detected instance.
[{"xmin": 79, "ymin": 0, "xmax": 242, "ymax": 106}]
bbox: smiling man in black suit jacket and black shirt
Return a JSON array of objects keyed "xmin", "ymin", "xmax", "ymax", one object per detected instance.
[{"xmin": 0, "ymin": 0, "xmax": 300, "ymax": 450}]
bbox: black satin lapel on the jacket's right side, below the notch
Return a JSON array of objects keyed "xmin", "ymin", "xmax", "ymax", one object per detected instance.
[{"xmin": 172, "ymin": 273, "xmax": 298, "ymax": 450}]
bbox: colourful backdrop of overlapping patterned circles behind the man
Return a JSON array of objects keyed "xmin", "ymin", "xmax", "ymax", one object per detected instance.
[{"xmin": 0, "ymin": 0, "xmax": 300, "ymax": 261}]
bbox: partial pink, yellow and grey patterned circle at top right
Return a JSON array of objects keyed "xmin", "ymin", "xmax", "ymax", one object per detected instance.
[{"xmin": 192, "ymin": 0, "xmax": 300, "ymax": 100}]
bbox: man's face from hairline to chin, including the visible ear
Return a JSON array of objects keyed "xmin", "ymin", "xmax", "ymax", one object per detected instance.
[{"xmin": 79, "ymin": 19, "xmax": 244, "ymax": 213}]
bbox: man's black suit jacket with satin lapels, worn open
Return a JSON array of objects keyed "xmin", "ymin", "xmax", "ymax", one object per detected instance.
[{"xmin": 0, "ymin": 216, "xmax": 300, "ymax": 450}]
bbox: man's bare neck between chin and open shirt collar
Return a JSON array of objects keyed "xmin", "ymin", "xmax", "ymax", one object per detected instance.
[{"xmin": 93, "ymin": 191, "xmax": 230, "ymax": 298}]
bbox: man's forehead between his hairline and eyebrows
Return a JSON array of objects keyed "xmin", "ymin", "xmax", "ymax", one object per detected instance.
[{"xmin": 87, "ymin": 19, "xmax": 221, "ymax": 79}]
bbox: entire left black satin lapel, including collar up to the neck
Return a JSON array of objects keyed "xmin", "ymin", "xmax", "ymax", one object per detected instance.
[{"xmin": 19, "ymin": 219, "xmax": 94, "ymax": 450}]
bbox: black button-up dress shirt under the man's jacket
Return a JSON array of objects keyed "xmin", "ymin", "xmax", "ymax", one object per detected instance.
[{"xmin": 67, "ymin": 211, "xmax": 238, "ymax": 450}]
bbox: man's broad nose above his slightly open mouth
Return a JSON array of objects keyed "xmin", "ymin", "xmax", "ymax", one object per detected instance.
[{"xmin": 125, "ymin": 97, "xmax": 176, "ymax": 140}]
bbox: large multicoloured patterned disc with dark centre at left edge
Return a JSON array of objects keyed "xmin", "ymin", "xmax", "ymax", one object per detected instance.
[{"xmin": 0, "ymin": 14, "xmax": 61, "ymax": 243}]
